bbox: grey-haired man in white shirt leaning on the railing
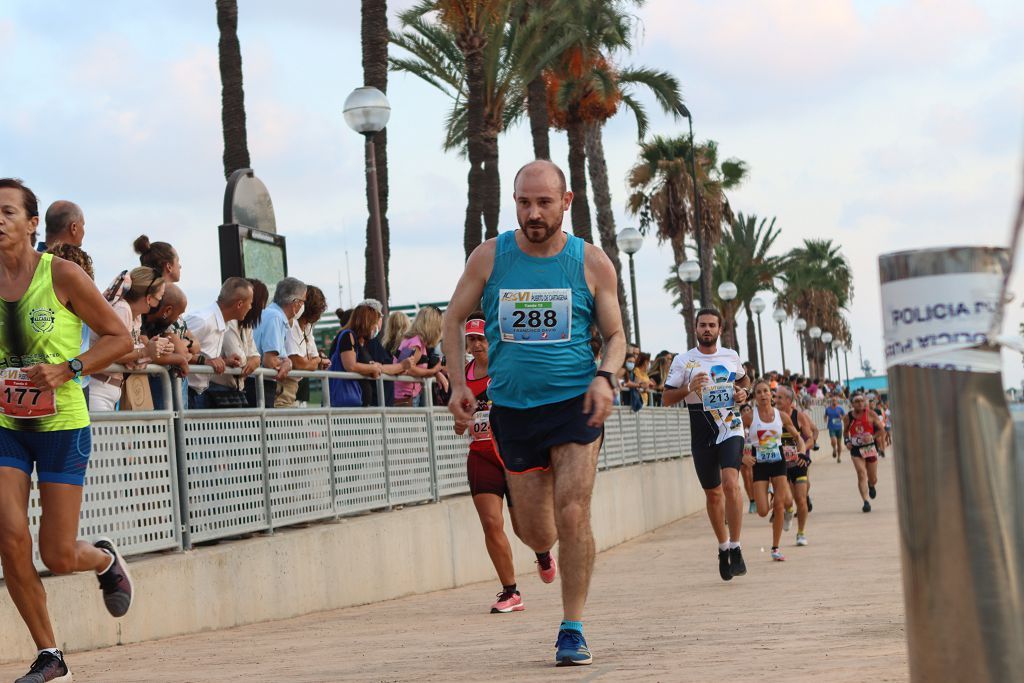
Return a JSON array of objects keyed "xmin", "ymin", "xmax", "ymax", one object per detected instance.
[{"xmin": 185, "ymin": 278, "xmax": 253, "ymax": 409}]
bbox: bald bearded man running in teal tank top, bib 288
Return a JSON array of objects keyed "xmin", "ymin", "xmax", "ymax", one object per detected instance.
[{"xmin": 444, "ymin": 161, "xmax": 626, "ymax": 667}]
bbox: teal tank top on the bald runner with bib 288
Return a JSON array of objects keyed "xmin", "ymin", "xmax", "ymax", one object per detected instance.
[{"xmin": 483, "ymin": 230, "xmax": 597, "ymax": 410}]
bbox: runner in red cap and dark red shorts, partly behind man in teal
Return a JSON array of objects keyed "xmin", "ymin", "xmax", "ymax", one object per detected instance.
[{"xmin": 455, "ymin": 311, "xmax": 525, "ymax": 614}]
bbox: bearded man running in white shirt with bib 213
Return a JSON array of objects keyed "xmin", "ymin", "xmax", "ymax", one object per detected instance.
[{"xmin": 662, "ymin": 308, "xmax": 750, "ymax": 581}]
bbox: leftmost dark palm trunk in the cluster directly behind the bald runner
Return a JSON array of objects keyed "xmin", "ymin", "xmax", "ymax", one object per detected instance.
[{"xmin": 463, "ymin": 46, "xmax": 486, "ymax": 259}]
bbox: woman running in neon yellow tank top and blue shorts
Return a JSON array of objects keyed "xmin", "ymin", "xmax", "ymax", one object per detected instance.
[{"xmin": 0, "ymin": 178, "xmax": 132, "ymax": 681}]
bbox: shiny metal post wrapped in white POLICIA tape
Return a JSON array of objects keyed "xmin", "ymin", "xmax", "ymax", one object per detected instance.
[{"xmin": 879, "ymin": 247, "xmax": 1024, "ymax": 683}]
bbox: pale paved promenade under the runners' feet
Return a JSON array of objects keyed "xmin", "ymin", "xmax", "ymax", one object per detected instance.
[{"xmin": 0, "ymin": 446, "xmax": 908, "ymax": 683}]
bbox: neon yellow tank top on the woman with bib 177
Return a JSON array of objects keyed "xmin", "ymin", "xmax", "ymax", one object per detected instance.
[{"xmin": 0, "ymin": 254, "xmax": 89, "ymax": 432}]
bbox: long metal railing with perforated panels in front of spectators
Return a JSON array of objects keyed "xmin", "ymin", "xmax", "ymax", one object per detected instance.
[{"xmin": 6, "ymin": 366, "xmax": 824, "ymax": 569}]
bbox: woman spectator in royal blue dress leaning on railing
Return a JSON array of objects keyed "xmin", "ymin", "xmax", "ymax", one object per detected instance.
[{"xmin": 329, "ymin": 304, "xmax": 407, "ymax": 408}]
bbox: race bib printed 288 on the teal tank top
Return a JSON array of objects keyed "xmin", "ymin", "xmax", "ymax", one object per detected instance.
[{"xmin": 498, "ymin": 289, "xmax": 572, "ymax": 344}]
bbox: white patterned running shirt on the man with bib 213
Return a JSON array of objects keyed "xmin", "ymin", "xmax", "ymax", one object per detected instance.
[{"xmin": 665, "ymin": 347, "xmax": 745, "ymax": 443}]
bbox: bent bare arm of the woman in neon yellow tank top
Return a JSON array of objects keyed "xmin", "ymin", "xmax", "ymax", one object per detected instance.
[{"xmin": 25, "ymin": 259, "xmax": 133, "ymax": 389}]
